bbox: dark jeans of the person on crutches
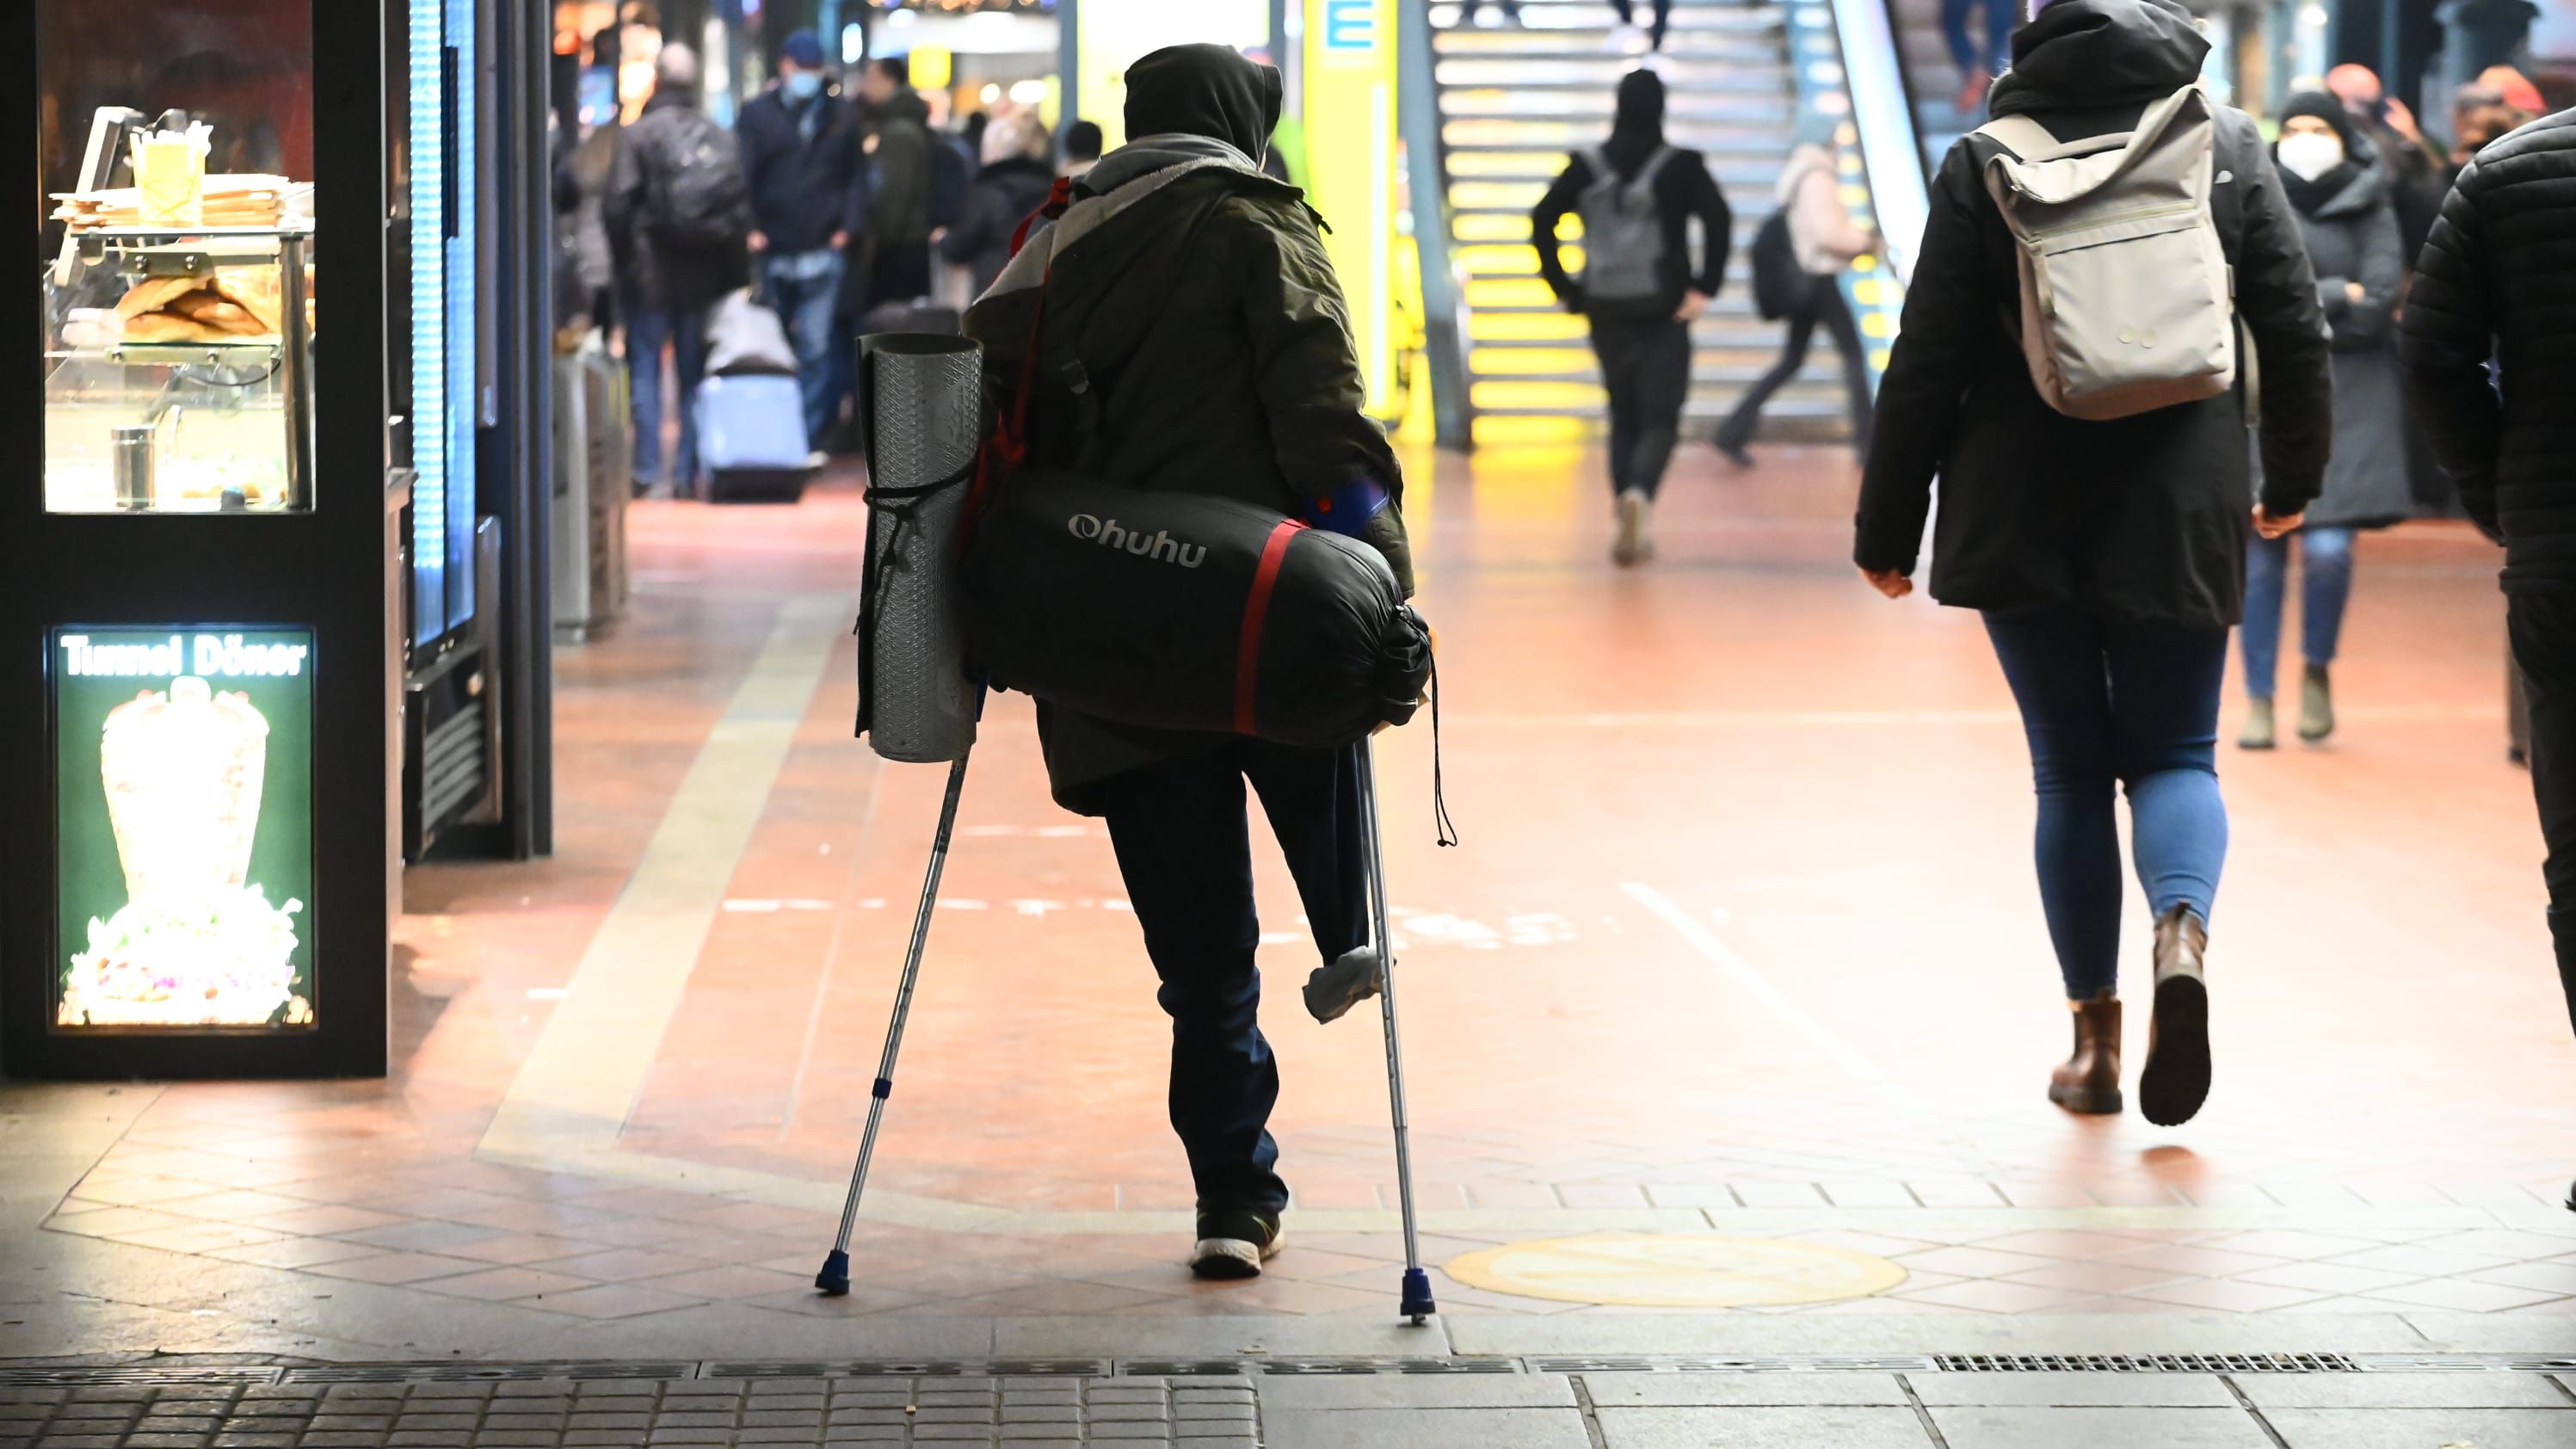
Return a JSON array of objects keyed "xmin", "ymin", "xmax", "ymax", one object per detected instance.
[{"xmin": 1097, "ymin": 740, "xmax": 1368, "ymax": 1212}]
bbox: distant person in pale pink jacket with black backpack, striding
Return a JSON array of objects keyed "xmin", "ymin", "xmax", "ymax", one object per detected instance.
[{"xmin": 1718, "ymin": 142, "xmax": 1878, "ymax": 466}]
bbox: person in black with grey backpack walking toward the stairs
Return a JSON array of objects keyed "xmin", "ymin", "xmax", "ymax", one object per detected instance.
[{"xmin": 1530, "ymin": 70, "xmax": 1734, "ymax": 564}]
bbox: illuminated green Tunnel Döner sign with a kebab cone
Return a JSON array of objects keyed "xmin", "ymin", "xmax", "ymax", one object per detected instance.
[{"xmin": 49, "ymin": 624, "xmax": 327, "ymax": 1034}]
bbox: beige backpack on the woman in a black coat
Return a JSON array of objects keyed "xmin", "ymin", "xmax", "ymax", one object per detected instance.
[{"xmin": 1975, "ymin": 85, "xmax": 2236, "ymax": 420}]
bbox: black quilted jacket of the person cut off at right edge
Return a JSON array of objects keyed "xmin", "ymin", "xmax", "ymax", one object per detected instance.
[{"xmin": 2398, "ymin": 111, "xmax": 2576, "ymax": 590}]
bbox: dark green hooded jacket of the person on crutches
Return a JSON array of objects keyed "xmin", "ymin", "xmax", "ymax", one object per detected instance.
[{"xmin": 966, "ymin": 46, "xmax": 1412, "ymax": 812}]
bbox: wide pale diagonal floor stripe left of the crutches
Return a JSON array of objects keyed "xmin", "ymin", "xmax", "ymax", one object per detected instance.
[{"xmin": 491, "ymin": 593, "xmax": 850, "ymax": 1168}]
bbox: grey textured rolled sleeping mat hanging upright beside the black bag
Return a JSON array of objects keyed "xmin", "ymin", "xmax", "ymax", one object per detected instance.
[{"xmin": 858, "ymin": 333, "xmax": 984, "ymax": 763}]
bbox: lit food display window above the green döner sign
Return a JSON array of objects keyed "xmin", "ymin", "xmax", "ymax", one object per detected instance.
[{"xmin": 34, "ymin": 0, "xmax": 319, "ymax": 513}]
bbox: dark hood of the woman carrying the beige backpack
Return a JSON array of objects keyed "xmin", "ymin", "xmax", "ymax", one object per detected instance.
[{"xmin": 1988, "ymin": 0, "xmax": 2210, "ymax": 116}]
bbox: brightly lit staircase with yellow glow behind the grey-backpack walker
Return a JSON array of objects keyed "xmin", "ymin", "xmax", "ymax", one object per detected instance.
[{"xmin": 1430, "ymin": 0, "xmax": 1850, "ymax": 443}]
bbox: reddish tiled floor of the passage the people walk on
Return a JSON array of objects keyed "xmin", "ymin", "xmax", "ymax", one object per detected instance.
[{"xmin": 0, "ymin": 433, "xmax": 2576, "ymax": 1361}]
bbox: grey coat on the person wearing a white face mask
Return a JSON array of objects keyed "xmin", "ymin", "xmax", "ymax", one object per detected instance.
[{"xmin": 2290, "ymin": 165, "xmax": 2416, "ymax": 528}]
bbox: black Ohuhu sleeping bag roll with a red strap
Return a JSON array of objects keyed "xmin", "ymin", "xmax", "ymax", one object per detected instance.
[{"xmin": 966, "ymin": 469, "xmax": 1433, "ymax": 748}]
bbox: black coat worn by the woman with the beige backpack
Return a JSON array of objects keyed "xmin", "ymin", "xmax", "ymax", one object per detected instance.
[{"xmin": 1852, "ymin": 0, "xmax": 2334, "ymax": 626}]
